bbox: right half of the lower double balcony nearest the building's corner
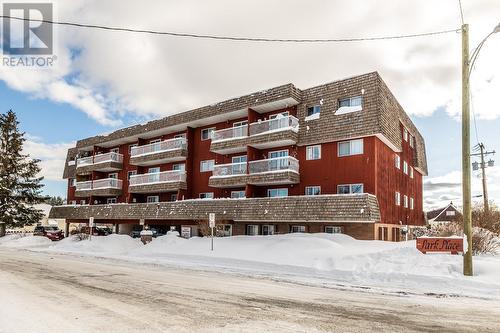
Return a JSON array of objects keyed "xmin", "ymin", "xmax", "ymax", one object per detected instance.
[{"xmin": 247, "ymin": 156, "xmax": 300, "ymax": 186}]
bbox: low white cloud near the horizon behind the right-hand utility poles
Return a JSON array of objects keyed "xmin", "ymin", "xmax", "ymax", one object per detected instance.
[{"xmin": 424, "ymin": 166, "xmax": 500, "ymax": 210}]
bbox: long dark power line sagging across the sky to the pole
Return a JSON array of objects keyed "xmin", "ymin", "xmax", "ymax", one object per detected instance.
[{"xmin": 0, "ymin": 15, "xmax": 460, "ymax": 43}]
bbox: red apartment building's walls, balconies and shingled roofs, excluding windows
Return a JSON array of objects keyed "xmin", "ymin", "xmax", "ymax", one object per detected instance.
[{"xmin": 51, "ymin": 72, "xmax": 427, "ymax": 240}]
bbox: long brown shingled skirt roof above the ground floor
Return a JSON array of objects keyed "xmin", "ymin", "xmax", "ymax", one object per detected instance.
[{"xmin": 49, "ymin": 194, "xmax": 380, "ymax": 222}]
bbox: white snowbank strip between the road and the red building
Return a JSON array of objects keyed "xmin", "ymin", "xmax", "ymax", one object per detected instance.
[{"xmin": 0, "ymin": 234, "xmax": 500, "ymax": 299}]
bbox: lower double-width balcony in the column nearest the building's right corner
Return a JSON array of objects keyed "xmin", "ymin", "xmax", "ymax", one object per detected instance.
[{"xmin": 208, "ymin": 156, "xmax": 300, "ymax": 188}]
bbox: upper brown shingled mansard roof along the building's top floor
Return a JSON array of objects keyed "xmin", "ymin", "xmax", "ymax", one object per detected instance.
[{"xmin": 64, "ymin": 72, "xmax": 427, "ymax": 178}]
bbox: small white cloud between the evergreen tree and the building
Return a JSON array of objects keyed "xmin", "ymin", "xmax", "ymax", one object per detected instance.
[{"xmin": 23, "ymin": 140, "xmax": 75, "ymax": 181}]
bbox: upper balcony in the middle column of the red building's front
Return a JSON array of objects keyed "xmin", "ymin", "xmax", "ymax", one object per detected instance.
[{"xmin": 130, "ymin": 138, "xmax": 187, "ymax": 166}]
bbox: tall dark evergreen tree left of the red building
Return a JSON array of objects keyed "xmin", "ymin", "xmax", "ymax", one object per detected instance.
[{"xmin": 0, "ymin": 110, "xmax": 43, "ymax": 228}]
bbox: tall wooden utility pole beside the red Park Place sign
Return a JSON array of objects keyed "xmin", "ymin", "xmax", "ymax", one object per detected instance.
[{"xmin": 462, "ymin": 24, "xmax": 473, "ymax": 276}]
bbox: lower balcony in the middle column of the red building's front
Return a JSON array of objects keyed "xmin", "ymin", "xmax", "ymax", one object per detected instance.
[{"xmin": 128, "ymin": 170, "xmax": 187, "ymax": 193}]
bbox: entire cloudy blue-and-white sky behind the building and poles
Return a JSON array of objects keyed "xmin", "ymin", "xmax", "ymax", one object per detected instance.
[{"xmin": 0, "ymin": 0, "xmax": 500, "ymax": 208}]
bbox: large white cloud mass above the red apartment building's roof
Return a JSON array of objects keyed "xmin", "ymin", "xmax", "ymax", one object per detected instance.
[{"xmin": 0, "ymin": 0, "xmax": 500, "ymax": 125}]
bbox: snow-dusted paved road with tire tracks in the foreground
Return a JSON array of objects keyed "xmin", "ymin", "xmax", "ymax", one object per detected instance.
[{"xmin": 0, "ymin": 248, "xmax": 500, "ymax": 333}]
